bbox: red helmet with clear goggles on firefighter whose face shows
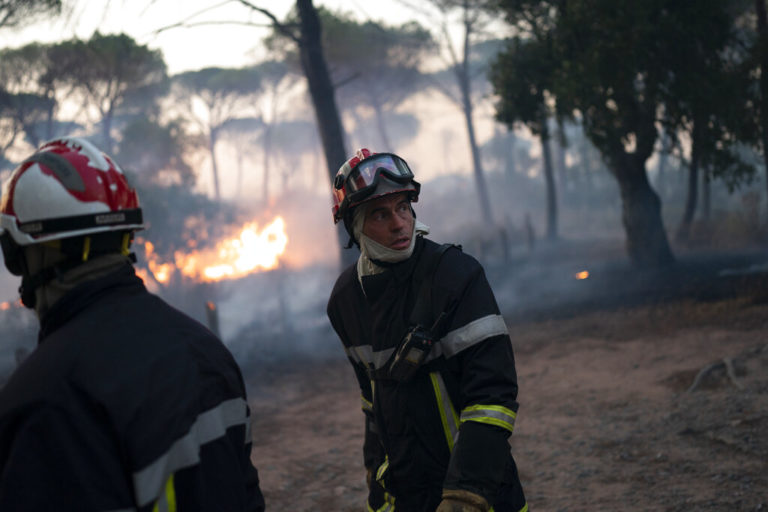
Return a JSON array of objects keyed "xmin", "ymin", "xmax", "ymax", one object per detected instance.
[{"xmin": 333, "ymin": 148, "xmax": 421, "ymax": 224}]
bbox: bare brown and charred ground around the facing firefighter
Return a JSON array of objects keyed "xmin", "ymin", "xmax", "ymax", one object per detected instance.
[{"xmin": 249, "ymin": 247, "xmax": 768, "ymax": 512}]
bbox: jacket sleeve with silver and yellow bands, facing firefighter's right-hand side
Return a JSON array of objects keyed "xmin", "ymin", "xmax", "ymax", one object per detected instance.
[{"xmin": 441, "ymin": 254, "xmax": 518, "ymax": 501}]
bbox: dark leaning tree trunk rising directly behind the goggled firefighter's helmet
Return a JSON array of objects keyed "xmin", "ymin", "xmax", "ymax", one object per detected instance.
[{"xmin": 296, "ymin": 0, "xmax": 357, "ymax": 267}]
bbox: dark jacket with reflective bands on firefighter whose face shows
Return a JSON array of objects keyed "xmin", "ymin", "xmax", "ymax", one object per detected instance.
[{"xmin": 328, "ymin": 237, "xmax": 527, "ymax": 512}]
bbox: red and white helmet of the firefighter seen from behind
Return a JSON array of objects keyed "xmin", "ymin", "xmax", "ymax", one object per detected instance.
[{"xmin": 0, "ymin": 137, "xmax": 144, "ymax": 246}]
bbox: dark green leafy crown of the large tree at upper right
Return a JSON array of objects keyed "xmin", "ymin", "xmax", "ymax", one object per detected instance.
[{"xmin": 491, "ymin": 0, "xmax": 754, "ymax": 184}]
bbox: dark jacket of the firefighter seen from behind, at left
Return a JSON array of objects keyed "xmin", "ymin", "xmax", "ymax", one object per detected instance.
[{"xmin": 0, "ymin": 264, "xmax": 264, "ymax": 512}]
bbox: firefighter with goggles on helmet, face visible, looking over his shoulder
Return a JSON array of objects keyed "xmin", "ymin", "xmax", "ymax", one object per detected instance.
[{"xmin": 328, "ymin": 149, "xmax": 528, "ymax": 512}]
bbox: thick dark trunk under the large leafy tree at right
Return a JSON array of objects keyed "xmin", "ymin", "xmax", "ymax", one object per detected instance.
[{"xmin": 610, "ymin": 154, "xmax": 675, "ymax": 268}]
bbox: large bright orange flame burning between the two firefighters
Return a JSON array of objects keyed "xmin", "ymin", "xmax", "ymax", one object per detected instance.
[{"xmin": 140, "ymin": 217, "xmax": 288, "ymax": 283}]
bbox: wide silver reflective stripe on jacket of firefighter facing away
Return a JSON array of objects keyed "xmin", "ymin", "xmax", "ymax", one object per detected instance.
[{"xmin": 133, "ymin": 398, "xmax": 251, "ymax": 507}]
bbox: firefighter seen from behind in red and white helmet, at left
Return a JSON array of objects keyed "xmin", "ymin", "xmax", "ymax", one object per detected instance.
[{"xmin": 0, "ymin": 138, "xmax": 264, "ymax": 512}]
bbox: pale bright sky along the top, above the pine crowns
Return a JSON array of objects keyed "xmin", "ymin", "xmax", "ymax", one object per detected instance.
[{"xmin": 0, "ymin": 0, "xmax": 414, "ymax": 74}]
